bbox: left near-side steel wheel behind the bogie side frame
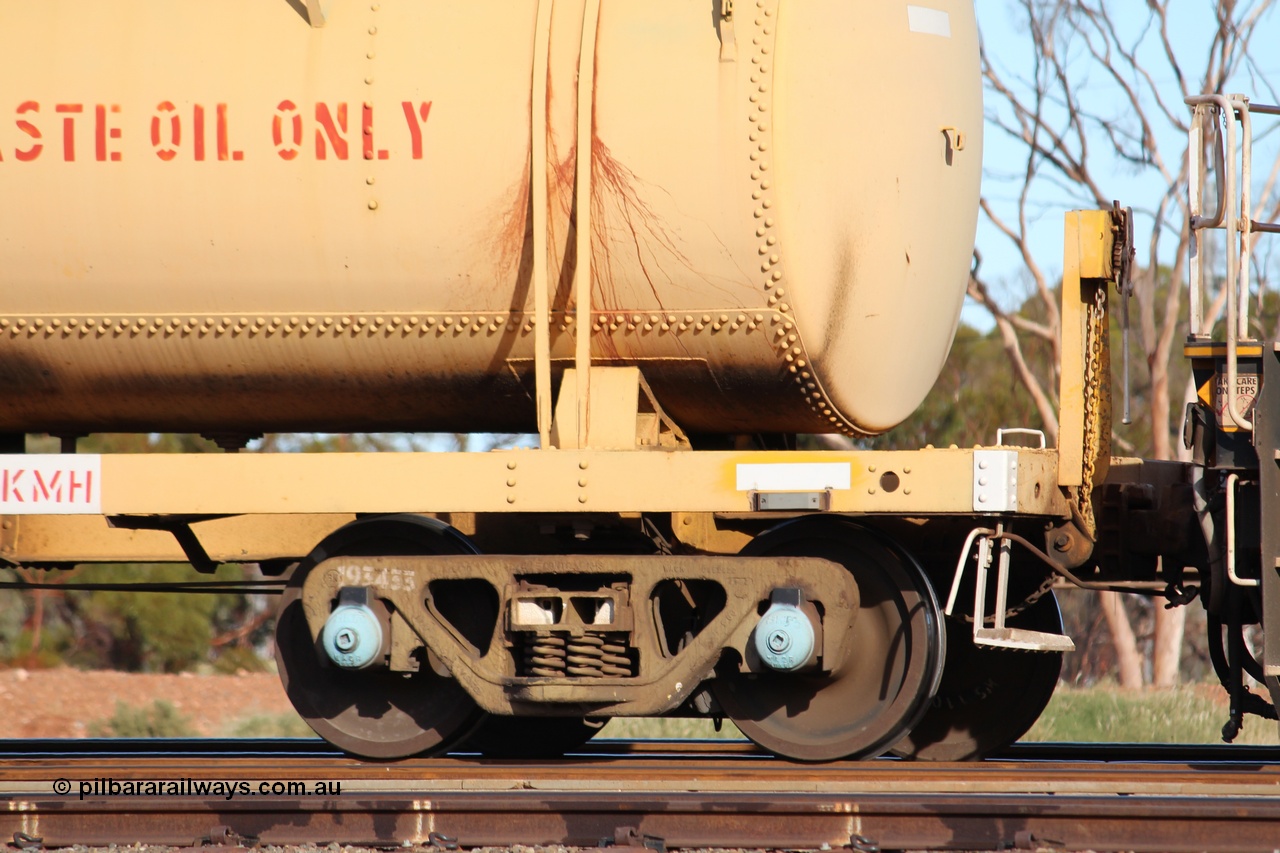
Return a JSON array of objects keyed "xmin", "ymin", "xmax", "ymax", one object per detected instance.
[{"xmin": 275, "ymin": 516, "xmax": 484, "ymax": 758}]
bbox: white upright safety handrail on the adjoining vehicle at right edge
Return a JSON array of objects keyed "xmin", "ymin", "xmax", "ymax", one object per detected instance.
[{"xmin": 1185, "ymin": 95, "xmax": 1280, "ymax": 430}]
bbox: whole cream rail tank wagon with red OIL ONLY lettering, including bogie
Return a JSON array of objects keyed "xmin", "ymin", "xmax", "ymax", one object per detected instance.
[{"xmin": 0, "ymin": 0, "xmax": 1110, "ymax": 760}]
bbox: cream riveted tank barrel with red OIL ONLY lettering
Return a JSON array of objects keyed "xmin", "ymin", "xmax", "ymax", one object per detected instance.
[{"xmin": 0, "ymin": 0, "xmax": 982, "ymax": 433}]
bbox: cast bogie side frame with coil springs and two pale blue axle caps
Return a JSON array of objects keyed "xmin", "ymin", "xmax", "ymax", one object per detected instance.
[{"xmin": 302, "ymin": 555, "xmax": 859, "ymax": 716}]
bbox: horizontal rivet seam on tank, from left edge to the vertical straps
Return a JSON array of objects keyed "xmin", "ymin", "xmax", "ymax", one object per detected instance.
[{"xmin": 0, "ymin": 311, "xmax": 560, "ymax": 338}]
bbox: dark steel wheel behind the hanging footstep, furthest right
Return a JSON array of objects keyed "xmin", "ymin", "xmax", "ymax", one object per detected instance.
[{"xmin": 893, "ymin": 584, "xmax": 1062, "ymax": 761}]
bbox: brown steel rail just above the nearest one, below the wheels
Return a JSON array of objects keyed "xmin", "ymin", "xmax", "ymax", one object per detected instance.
[{"xmin": 0, "ymin": 754, "xmax": 1280, "ymax": 797}]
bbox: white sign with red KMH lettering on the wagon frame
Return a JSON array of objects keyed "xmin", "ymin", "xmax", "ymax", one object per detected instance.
[{"xmin": 0, "ymin": 453, "xmax": 102, "ymax": 515}]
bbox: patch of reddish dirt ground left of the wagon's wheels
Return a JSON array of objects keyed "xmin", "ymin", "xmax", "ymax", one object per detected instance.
[{"xmin": 0, "ymin": 667, "xmax": 293, "ymax": 738}]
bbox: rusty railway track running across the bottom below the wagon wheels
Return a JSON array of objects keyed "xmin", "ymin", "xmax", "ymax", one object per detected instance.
[{"xmin": 0, "ymin": 742, "xmax": 1280, "ymax": 850}]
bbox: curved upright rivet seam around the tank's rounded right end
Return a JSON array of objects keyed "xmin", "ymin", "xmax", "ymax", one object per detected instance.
[{"xmin": 748, "ymin": 0, "xmax": 858, "ymax": 434}]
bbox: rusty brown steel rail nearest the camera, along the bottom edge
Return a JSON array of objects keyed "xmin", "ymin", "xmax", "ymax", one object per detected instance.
[{"xmin": 0, "ymin": 790, "xmax": 1280, "ymax": 852}]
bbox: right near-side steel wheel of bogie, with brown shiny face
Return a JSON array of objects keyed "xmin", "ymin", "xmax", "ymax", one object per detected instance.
[{"xmin": 713, "ymin": 516, "xmax": 946, "ymax": 761}]
